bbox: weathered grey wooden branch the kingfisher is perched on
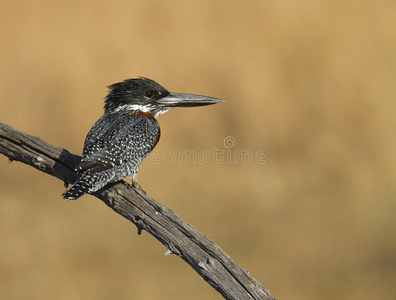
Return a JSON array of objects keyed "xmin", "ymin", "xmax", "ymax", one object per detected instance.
[{"xmin": 0, "ymin": 123, "xmax": 274, "ymax": 300}]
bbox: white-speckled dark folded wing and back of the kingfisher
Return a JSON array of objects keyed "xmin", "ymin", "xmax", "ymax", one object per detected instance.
[{"xmin": 76, "ymin": 114, "xmax": 159, "ymax": 173}]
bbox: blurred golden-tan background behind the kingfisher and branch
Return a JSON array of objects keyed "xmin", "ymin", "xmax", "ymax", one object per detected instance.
[{"xmin": 0, "ymin": 0, "xmax": 396, "ymax": 300}]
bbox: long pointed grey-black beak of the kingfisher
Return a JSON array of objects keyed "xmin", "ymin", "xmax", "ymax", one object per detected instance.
[{"xmin": 157, "ymin": 93, "xmax": 224, "ymax": 107}]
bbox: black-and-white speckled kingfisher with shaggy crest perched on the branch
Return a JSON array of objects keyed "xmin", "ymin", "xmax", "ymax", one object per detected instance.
[{"xmin": 62, "ymin": 77, "xmax": 223, "ymax": 200}]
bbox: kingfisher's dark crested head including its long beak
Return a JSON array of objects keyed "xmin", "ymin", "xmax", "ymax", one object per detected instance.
[{"xmin": 104, "ymin": 77, "xmax": 223, "ymax": 117}]
